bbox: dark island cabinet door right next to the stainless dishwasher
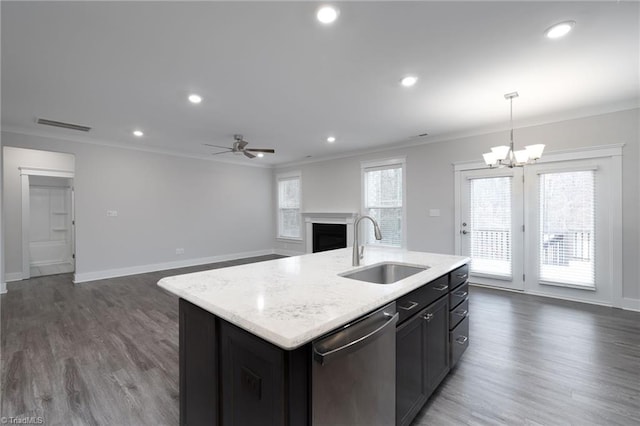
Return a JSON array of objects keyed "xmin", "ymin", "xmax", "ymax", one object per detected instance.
[{"xmin": 396, "ymin": 312, "xmax": 427, "ymax": 426}]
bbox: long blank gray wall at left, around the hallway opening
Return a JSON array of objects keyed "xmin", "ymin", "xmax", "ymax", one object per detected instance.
[{"xmin": 2, "ymin": 132, "xmax": 274, "ymax": 281}]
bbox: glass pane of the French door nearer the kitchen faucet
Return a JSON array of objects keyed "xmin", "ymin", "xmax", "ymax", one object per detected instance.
[{"xmin": 464, "ymin": 177, "xmax": 512, "ymax": 278}]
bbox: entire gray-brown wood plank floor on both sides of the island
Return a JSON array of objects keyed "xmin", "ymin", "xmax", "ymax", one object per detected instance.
[{"xmin": 0, "ymin": 262, "xmax": 640, "ymax": 426}]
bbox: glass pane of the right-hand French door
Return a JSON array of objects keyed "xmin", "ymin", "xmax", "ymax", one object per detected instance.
[{"xmin": 538, "ymin": 170, "xmax": 595, "ymax": 288}]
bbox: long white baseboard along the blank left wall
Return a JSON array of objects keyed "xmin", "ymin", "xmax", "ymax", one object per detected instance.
[{"xmin": 73, "ymin": 249, "xmax": 274, "ymax": 284}]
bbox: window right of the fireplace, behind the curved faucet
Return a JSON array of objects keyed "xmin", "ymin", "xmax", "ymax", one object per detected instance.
[{"xmin": 362, "ymin": 159, "xmax": 405, "ymax": 247}]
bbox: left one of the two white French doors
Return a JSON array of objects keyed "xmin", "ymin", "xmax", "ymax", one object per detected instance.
[{"xmin": 459, "ymin": 169, "xmax": 524, "ymax": 290}]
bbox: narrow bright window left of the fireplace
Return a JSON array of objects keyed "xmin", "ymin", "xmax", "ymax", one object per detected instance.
[{"xmin": 277, "ymin": 172, "xmax": 302, "ymax": 239}]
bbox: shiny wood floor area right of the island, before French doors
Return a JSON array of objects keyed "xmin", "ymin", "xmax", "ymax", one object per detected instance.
[{"xmin": 413, "ymin": 287, "xmax": 640, "ymax": 426}]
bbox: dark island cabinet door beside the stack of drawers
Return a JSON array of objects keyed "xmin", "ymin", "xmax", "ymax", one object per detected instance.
[{"xmin": 422, "ymin": 297, "xmax": 449, "ymax": 396}]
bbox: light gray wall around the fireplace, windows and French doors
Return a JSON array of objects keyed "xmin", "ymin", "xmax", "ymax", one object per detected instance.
[{"xmin": 274, "ymin": 109, "xmax": 640, "ymax": 299}]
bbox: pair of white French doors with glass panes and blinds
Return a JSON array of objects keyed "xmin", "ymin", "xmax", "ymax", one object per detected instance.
[{"xmin": 457, "ymin": 153, "xmax": 620, "ymax": 305}]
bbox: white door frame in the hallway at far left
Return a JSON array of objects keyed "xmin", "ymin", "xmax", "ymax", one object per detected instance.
[{"xmin": 18, "ymin": 167, "xmax": 76, "ymax": 280}]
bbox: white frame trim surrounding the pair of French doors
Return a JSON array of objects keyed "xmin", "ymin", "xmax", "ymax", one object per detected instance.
[{"xmin": 453, "ymin": 143, "xmax": 624, "ymax": 308}]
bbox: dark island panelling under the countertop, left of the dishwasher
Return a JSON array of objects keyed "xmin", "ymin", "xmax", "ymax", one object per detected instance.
[{"xmin": 180, "ymin": 299, "xmax": 311, "ymax": 426}]
